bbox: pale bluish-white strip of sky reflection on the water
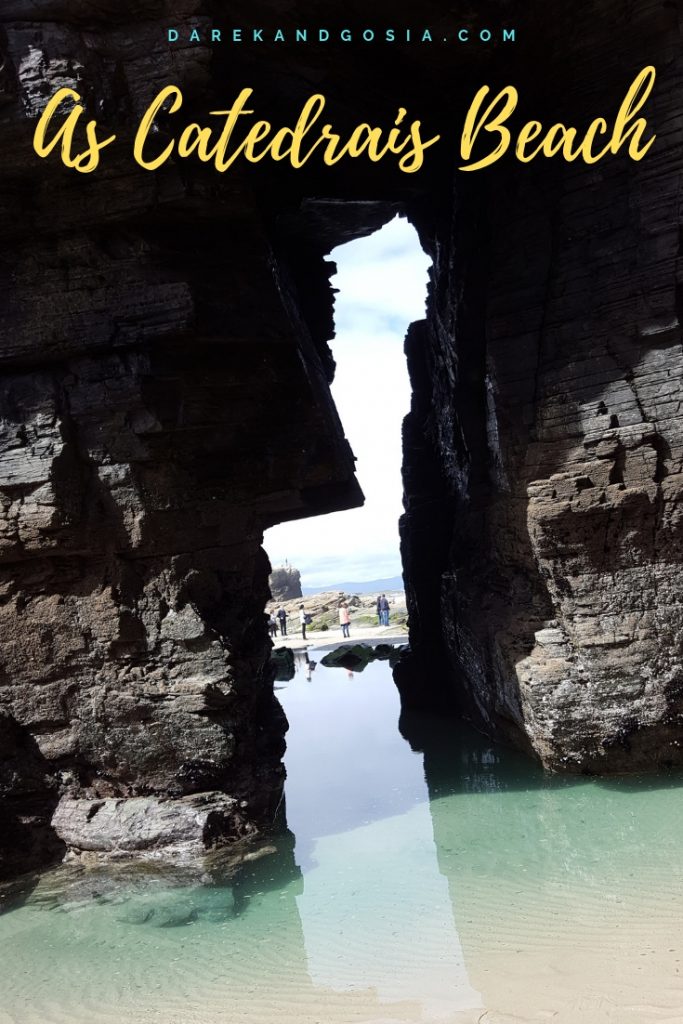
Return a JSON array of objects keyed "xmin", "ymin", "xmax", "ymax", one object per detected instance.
[{"xmin": 281, "ymin": 651, "xmax": 481, "ymax": 1021}]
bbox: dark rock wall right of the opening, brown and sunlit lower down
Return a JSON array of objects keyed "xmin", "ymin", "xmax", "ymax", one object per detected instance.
[{"xmin": 399, "ymin": 2, "xmax": 683, "ymax": 771}]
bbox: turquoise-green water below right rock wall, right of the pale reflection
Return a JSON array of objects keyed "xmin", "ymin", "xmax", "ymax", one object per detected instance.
[{"xmin": 400, "ymin": 713, "xmax": 683, "ymax": 1024}]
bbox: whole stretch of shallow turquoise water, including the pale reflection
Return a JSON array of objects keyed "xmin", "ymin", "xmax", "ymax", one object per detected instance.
[{"xmin": 0, "ymin": 655, "xmax": 683, "ymax": 1024}]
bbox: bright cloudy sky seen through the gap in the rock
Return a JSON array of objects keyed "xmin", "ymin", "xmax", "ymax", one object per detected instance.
[{"xmin": 264, "ymin": 217, "xmax": 429, "ymax": 587}]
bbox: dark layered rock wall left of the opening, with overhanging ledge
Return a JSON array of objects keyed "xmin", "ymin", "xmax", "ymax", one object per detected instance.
[{"xmin": 0, "ymin": 3, "xmax": 368, "ymax": 871}]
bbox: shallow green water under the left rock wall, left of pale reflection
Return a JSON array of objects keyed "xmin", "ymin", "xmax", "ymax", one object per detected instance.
[{"xmin": 0, "ymin": 815, "xmax": 438, "ymax": 1024}]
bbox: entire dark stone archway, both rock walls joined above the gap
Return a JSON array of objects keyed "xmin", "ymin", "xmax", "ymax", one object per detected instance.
[{"xmin": 0, "ymin": 0, "xmax": 683, "ymax": 871}]
